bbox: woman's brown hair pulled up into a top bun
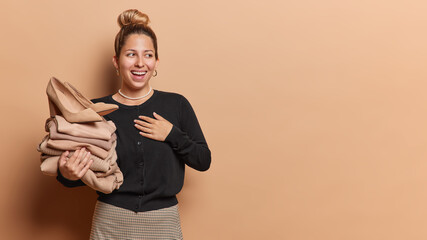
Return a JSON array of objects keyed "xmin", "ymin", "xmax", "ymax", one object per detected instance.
[{"xmin": 114, "ymin": 9, "xmax": 159, "ymax": 59}]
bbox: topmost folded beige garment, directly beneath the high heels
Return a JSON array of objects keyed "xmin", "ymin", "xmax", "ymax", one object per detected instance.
[{"xmin": 54, "ymin": 115, "xmax": 116, "ymax": 141}]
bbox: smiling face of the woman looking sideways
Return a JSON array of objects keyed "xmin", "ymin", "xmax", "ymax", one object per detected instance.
[{"xmin": 113, "ymin": 34, "xmax": 158, "ymax": 90}]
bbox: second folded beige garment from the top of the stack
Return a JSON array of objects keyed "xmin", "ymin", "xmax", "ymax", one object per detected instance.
[{"xmin": 45, "ymin": 118, "xmax": 117, "ymax": 151}]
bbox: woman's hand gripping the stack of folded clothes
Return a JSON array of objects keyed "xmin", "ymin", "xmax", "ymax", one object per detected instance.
[{"xmin": 58, "ymin": 148, "xmax": 93, "ymax": 181}]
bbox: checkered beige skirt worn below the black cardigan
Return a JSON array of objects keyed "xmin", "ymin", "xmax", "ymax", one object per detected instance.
[{"xmin": 90, "ymin": 201, "xmax": 183, "ymax": 240}]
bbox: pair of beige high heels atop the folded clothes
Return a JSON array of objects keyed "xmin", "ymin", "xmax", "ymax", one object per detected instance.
[{"xmin": 46, "ymin": 77, "xmax": 119, "ymax": 123}]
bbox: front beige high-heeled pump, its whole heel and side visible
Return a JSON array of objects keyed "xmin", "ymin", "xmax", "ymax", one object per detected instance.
[{"xmin": 46, "ymin": 77, "xmax": 103, "ymax": 123}]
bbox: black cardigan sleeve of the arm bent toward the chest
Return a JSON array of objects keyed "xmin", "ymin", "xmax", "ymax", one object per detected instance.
[{"xmin": 165, "ymin": 96, "xmax": 211, "ymax": 171}]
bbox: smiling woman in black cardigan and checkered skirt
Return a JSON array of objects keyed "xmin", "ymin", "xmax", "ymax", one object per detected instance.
[{"xmin": 57, "ymin": 9, "xmax": 211, "ymax": 239}]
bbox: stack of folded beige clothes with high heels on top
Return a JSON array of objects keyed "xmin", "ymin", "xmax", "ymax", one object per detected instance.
[{"xmin": 37, "ymin": 77, "xmax": 123, "ymax": 193}]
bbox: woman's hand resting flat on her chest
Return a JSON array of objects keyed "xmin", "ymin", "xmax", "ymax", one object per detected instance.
[{"xmin": 135, "ymin": 112, "xmax": 173, "ymax": 142}]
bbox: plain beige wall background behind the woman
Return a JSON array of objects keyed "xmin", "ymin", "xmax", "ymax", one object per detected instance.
[{"xmin": 0, "ymin": 0, "xmax": 427, "ymax": 240}]
